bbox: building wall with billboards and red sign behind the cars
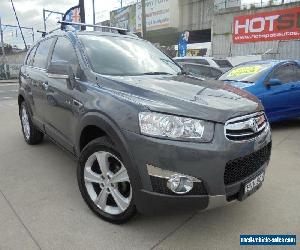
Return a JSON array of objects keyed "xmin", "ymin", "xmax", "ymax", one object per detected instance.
[{"xmin": 105, "ymin": 0, "xmax": 300, "ymax": 59}]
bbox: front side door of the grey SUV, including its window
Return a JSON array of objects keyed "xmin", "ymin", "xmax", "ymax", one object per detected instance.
[{"xmin": 44, "ymin": 36, "xmax": 81, "ymax": 151}]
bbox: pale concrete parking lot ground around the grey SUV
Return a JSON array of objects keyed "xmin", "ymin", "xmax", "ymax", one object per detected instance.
[{"xmin": 0, "ymin": 82, "xmax": 300, "ymax": 249}]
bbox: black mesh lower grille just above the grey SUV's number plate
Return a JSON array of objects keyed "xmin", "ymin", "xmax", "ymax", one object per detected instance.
[{"xmin": 224, "ymin": 143, "xmax": 272, "ymax": 185}]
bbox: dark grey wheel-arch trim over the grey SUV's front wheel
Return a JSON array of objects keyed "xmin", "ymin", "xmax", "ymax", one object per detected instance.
[{"xmin": 75, "ymin": 112, "xmax": 142, "ymax": 189}]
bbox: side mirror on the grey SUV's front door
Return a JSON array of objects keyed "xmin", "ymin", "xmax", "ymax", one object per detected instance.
[{"xmin": 47, "ymin": 61, "xmax": 73, "ymax": 80}]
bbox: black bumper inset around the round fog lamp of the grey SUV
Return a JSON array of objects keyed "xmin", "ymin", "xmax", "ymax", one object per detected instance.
[{"xmin": 150, "ymin": 175, "xmax": 207, "ymax": 196}]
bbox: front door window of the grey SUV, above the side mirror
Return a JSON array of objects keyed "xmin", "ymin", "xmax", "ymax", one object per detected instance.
[{"xmin": 51, "ymin": 37, "xmax": 78, "ymax": 72}]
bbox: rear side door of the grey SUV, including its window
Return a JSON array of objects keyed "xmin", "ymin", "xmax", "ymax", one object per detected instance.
[{"xmin": 26, "ymin": 38, "xmax": 54, "ymax": 125}]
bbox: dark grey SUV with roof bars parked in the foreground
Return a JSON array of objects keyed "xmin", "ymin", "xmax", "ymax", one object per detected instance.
[{"xmin": 18, "ymin": 28, "xmax": 271, "ymax": 223}]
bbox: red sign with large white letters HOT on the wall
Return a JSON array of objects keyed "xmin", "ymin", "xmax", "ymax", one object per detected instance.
[{"xmin": 233, "ymin": 7, "xmax": 300, "ymax": 43}]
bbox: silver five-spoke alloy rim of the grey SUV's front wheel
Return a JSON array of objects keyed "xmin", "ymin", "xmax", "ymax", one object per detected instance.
[{"xmin": 84, "ymin": 151, "xmax": 132, "ymax": 215}]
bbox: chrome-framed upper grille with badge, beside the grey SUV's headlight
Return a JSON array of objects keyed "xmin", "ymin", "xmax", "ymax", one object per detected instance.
[{"xmin": 225, "ymin": 112, "xmax": 269, "ymax": 142}]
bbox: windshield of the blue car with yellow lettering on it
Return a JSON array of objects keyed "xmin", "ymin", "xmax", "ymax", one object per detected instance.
[{"xmin": 219, "ymin": 64, "xmax": 272, "ymax": 83}]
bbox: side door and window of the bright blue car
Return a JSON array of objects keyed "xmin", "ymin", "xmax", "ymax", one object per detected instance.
[{"xmin": 260, "ymin": 63, "xmax": 300, "ymax": 120}]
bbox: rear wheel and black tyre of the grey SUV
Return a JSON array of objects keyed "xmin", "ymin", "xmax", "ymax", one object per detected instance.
[{"xmin": 19, "ymin": 101, "xmax": 44, "ymax": 145}]
